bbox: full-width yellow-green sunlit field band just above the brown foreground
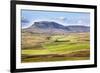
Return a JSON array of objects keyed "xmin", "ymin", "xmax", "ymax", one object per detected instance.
[{"xmin": 22, "ymin": 44, "xmax": 90, "ymax": 55}]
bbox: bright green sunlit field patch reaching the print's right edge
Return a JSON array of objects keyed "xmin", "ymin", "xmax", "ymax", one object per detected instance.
[{"xmin": 44, "ymin": 43, "xmax": 90, "ymax": 51}]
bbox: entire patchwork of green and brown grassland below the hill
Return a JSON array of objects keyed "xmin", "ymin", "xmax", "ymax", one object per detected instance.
[{"xmin": 21, "ymin": 32, "xmax": 90, "ymax": 63}]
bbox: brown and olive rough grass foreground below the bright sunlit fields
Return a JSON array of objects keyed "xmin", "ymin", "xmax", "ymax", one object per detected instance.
[{"xmin": 22, "ymin": 50, "xmax": 90, "ymax": 63}]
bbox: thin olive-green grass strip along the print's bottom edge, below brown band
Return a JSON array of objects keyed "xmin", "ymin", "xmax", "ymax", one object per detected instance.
[{"xmin": 22, "ymin": 57, "xmax": 89, "ymax": 63}]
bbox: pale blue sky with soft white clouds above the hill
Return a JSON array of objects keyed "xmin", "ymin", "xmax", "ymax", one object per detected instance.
[{"xmin": 21, "ymin": 10, "xmax": 90, "ymax": 28}]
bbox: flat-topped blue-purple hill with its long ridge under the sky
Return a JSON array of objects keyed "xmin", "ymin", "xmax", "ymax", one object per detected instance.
[{"xmin": 22, "ymin": 21, "xmax": 90, "ymax": 34}]
